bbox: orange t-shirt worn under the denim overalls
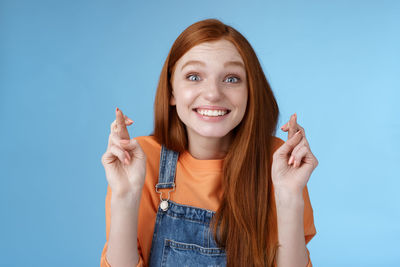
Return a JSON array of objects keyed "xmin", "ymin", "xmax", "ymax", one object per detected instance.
[{"xmin": 100, "ymin": 136, "xmax": 316, "ymax": 267}]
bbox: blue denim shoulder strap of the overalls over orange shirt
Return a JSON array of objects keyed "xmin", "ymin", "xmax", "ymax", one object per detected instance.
[{"xmin": 156, "ymin": 145, "xmax": 179, "ymax": 191}]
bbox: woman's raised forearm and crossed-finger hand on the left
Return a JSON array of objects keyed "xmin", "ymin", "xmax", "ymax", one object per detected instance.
[{"xmin": 101, "ymin": 108, "xmax": 146, "ymax": 267}]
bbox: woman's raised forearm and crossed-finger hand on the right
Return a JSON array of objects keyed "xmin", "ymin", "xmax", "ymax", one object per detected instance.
[{"xmin": 272, "ymin": 114, "xmax": 318, "ymax": 267}]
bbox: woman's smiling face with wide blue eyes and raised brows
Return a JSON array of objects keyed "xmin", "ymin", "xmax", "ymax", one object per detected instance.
[{"xmin": 170, "ymin": 40, "xmax": 248, "ymax": 143}]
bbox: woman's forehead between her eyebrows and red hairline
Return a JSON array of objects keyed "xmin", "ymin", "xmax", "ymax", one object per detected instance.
[{"xmin": 177, "ymin": 39, "xmax": 244, "ymax": 65}]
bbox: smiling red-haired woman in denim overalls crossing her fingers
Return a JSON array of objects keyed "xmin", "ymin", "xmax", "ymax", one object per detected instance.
[{"xmin": 101, "ymin": 20, "xmax": 318, "ymax": 267}]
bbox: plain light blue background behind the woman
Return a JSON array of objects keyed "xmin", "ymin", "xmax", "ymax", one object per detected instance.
[{"xmin": 0, "ymin": 0, "xmax": 400, "ymax": 267}]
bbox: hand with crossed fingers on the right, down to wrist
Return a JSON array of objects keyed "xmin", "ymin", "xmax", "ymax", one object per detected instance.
[{"xmin": 271, "ymin": 114, "xmax": 318, "ymax": 194}]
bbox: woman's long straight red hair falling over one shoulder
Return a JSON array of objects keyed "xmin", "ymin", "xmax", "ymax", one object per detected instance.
[{"xmin": 154, "ymin": 19, "xmax": 279, "ymax": 267}]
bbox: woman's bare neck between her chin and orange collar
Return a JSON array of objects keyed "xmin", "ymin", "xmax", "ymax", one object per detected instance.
[{"xmin": 188, "ymin": 134, "xmax": 232, "ymax": 160}]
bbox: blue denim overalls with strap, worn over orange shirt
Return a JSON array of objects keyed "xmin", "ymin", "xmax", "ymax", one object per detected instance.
[{"xmin": 149, "ymin": 146, "xmax": 226, "ymax": 267}]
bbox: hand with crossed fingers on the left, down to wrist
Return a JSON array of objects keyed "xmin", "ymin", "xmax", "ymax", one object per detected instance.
[{"xmin": 101, "ymin": 108, "xmax": 146, "ymax": 198}]
